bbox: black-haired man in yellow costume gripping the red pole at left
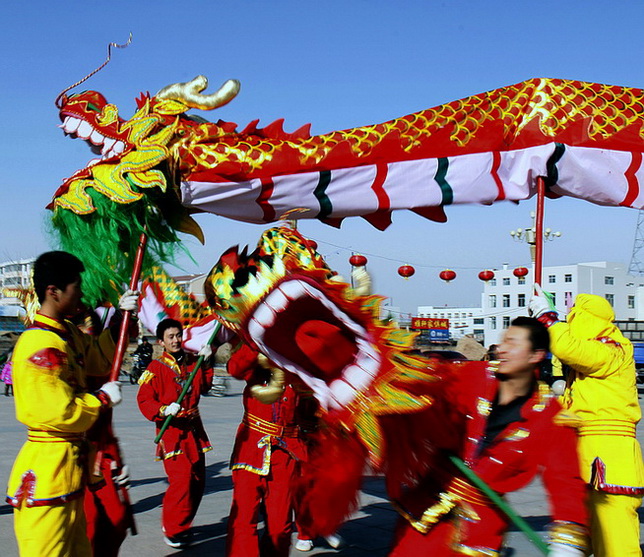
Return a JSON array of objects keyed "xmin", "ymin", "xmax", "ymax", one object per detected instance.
[{"xmin": 7, "ymin": 251, "xmax": 137, "ymax": 557}]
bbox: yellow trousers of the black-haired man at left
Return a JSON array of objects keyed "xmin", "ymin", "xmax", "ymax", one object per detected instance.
[{"xmin": 13, "ymin": 497, "xmax": 92, "ymax": 557}]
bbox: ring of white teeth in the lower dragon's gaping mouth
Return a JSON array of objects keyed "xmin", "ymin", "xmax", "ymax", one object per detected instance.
[{"xmin": 248, "ymin": 280, "xmax": 380, "ymax": 410}]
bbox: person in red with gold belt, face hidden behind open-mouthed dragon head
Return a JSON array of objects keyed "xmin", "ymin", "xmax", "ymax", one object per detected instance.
[{"xmin": 226, "ymin": 344, "xmax": 306, "ymax": 557}]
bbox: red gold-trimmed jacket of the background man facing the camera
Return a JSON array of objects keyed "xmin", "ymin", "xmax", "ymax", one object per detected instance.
[{"xmin": 136, "ymin": 351, "xmax": 213, "ymax": 462}]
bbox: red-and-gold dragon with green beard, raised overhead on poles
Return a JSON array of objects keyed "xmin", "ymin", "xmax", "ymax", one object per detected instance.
[{"xmin": 50, "ymin": 76, "xmax": 644, "ymax": 304}]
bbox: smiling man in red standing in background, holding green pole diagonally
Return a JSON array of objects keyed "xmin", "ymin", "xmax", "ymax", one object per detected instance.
[{"xmin": 137, "ymin": 319, "xmax": 213, "ymax": 548}]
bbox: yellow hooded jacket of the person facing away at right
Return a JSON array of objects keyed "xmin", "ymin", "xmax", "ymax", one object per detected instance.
[{"xmin": 548, "ymin": 294, "xmax": 644, "ymax": 495}]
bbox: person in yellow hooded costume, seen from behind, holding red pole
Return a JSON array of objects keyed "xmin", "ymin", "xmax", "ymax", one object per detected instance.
[{"xmin": 530, "ymin": 285, "xmax": 644, "ymax": 557}]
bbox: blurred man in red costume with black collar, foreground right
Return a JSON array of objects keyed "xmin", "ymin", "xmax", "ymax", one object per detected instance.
[{"xmin": 391, "ymin": 317, "xmax": 587, "ymax": 557}]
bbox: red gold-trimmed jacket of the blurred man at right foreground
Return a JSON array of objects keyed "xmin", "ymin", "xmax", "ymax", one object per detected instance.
[{"xmin": 402, "ymin": 362, "xmax": 588, "ymax": 525}]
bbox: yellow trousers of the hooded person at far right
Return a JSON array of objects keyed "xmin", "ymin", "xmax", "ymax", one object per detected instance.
[{"xmin": 589, "ymin": 489, "xmax": 642, "ymax": 557}]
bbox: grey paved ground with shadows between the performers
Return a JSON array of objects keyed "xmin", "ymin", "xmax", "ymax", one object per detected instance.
[{"xmin": 0, "ymin": 380, "xmax": 644, "ymax": 557}]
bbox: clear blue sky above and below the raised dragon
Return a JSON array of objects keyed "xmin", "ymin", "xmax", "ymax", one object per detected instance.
[{"xmin": 0, "ymin": 0, "xmax": 644, "ymax": 312}]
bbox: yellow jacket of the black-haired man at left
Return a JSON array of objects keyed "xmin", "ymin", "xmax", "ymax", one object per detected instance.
[{"xmin": 7, "ymin": 314, "xmax": 114, "ymax": 507}]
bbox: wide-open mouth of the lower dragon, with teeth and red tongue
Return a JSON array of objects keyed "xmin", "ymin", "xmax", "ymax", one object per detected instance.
[{"xmin": 248, "ymin": 279, "xmax": 381, "ymax": 410}]
